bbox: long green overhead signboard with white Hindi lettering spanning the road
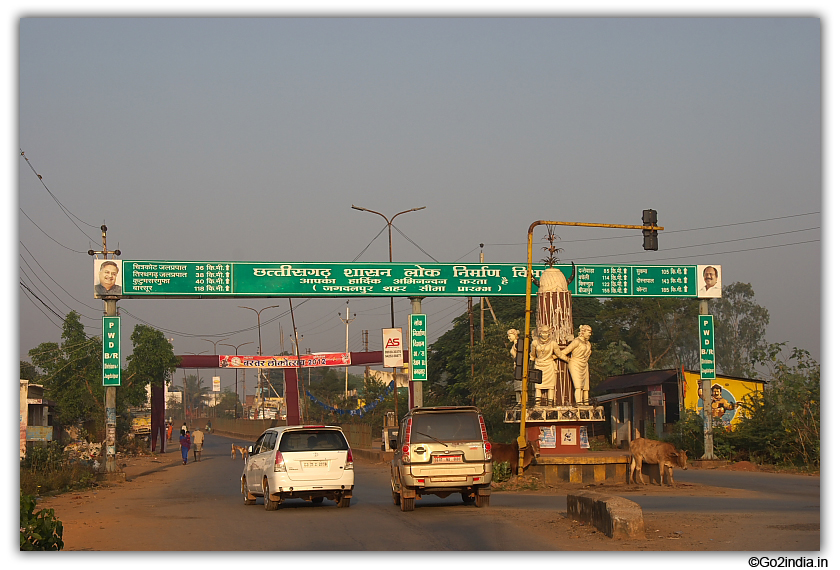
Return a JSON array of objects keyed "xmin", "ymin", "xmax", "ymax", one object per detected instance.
[{"xmin": 116, "ymin": 260, "xmax": 698, "ymax": 298}]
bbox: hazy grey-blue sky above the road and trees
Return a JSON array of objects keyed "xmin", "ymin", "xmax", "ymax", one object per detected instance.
[{"xmin": 14, "ymin": 12, "xmax": 823, "ymax": 385}]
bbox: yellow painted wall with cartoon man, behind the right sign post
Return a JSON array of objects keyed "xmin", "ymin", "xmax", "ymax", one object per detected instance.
[{"xmin": 683, "ymin": 371, "xmax": 764, "ymax": 430}]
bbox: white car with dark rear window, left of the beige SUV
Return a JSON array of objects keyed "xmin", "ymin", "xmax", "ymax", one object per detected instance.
[{"xmin": 241, "ymin": 426, "xmax": 354, "ymax": 511}]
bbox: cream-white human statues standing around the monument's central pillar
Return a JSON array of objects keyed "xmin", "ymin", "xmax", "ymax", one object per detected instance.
[{"xmin": 508, "ymin": 325, "xmax": 592, "ymax": 406}]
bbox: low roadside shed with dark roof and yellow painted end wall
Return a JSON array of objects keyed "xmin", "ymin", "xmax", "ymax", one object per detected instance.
[{"xmin": 593, "ymin": 368, "xmax": 764, "ymax": 446}]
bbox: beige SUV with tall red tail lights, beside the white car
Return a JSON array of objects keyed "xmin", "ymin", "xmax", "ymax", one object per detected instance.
[{"xmin": 389, "ymin": 406, "xmax": 493, "ymax": 511}]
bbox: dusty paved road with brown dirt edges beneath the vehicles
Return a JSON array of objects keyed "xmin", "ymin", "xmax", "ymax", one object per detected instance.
[{"xmin": 34, "ymin": 430, "xmax": 820, "ymax": 552}]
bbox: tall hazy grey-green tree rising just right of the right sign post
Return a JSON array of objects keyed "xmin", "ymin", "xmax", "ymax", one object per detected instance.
[{"xmin": 709, "ymin": 281, "xmax": 770, "ymax": 378}]
